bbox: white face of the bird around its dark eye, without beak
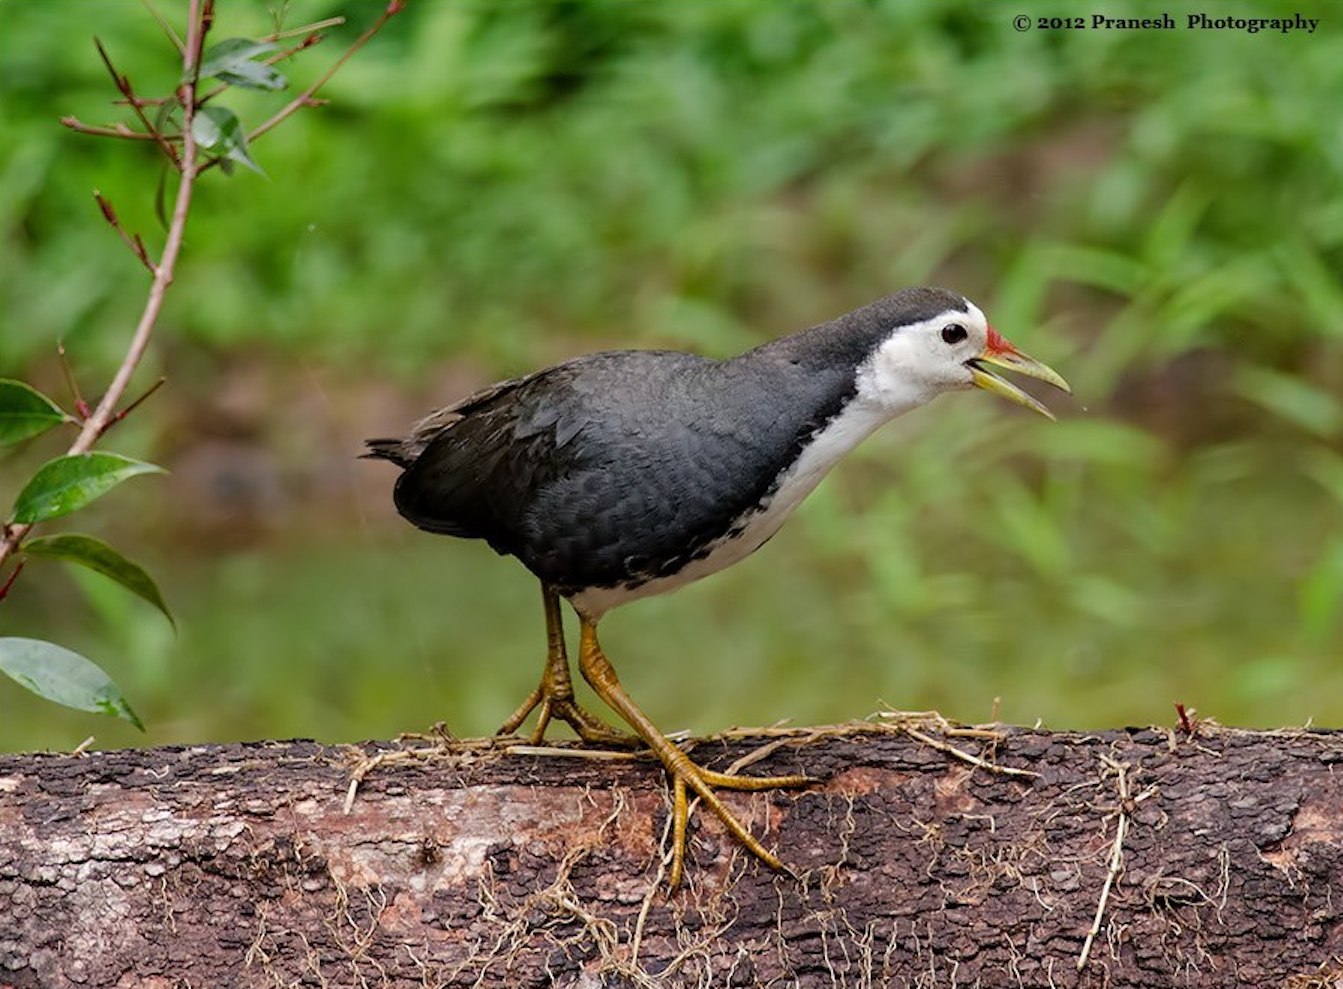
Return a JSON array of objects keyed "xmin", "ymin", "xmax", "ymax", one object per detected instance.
[{"xmin": 858, "ymin": 300, "xmax": 988, "ymax": 414}]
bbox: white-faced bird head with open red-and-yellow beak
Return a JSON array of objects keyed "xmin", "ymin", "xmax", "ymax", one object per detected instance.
[{"xmin": 858, "ymin": 289, "xmax": 1072, "ymax": 419}]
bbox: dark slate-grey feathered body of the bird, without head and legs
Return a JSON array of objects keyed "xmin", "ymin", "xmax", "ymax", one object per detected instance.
[{"xmin": 396, "ymin": 351, "xmax": 843, "ymax": 591}]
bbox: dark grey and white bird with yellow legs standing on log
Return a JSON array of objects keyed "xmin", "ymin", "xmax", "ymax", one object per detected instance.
[{"xmin": 363, "ymin": 286, "xmax": 1070, "ymax": 890}]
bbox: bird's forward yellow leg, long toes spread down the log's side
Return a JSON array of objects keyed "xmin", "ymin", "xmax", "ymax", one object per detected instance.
[{"xmin": 579, "ymin": 617, "xmax": 813, "ymax": 890}]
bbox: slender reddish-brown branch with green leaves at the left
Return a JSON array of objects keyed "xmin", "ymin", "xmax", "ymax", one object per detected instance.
[{"xmin": 0, "ymin": 0, "xmax": 400, "ymax": 730}]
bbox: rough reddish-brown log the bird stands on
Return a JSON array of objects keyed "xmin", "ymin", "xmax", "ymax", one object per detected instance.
[{"xmin": 0, "ymin": 726, "xmax": 1343, "ymax": 989}]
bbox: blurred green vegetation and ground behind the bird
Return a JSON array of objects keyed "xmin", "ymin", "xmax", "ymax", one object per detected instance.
[{"xmin": 0, "ymin": 0, "xmax": 1343, "ymax": 748}]
